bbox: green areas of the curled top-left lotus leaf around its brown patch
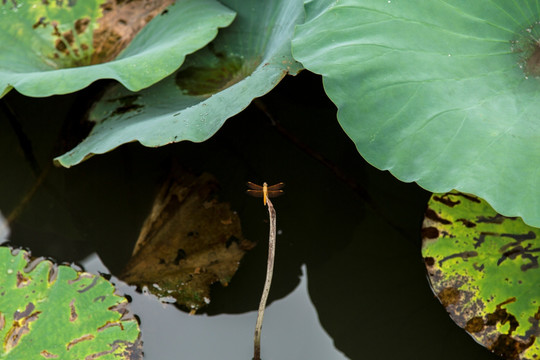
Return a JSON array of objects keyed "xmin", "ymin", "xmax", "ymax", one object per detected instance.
[{"xmin": 0, "ymin": 0, "xmax": 234, "ymax": 96}]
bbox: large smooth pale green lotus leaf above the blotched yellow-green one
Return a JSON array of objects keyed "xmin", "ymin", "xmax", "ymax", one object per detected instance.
[{"xmin": 293, "ymin": 0, "xmax": 540, "ymax": 226}]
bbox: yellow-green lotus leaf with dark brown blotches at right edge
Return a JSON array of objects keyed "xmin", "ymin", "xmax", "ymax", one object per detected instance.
[{"xmin": 422, "ymin": 192, "xmax": 540, "ymax": 360}]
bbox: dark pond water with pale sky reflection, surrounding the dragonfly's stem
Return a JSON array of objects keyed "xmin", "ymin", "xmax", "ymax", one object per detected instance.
[{"xmin": 0, "ymin": 73, "xmax": 498, "ymax": 360}]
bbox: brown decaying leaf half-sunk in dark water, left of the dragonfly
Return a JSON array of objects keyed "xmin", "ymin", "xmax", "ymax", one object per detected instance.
[{"xmin": 121, "ymin": 171, "xmax": 253, "ymax": 310}]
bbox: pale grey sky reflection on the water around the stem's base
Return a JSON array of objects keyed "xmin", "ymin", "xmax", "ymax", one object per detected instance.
[{"xmin": 82, "ymin": 253, "xmax": 347, "ymax": 360}]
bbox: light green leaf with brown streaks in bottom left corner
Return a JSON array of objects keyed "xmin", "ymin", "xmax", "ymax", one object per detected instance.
[{"xmin": 0, "ymin": 247, "xmax": 142, "ymax": 360}]
